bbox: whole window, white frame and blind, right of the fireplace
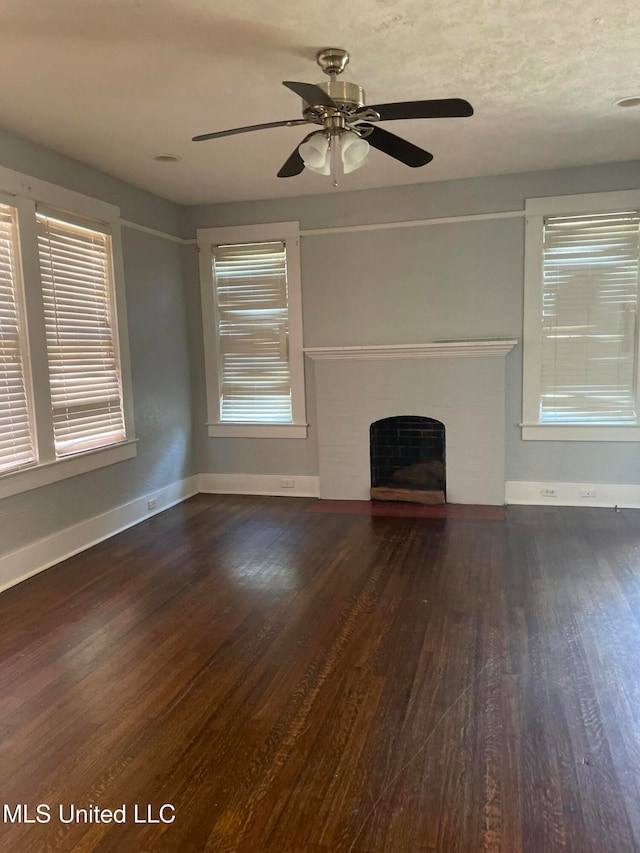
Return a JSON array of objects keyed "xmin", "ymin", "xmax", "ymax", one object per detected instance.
[{"xmin": 522, "ymin": 191, "xmax": 640, "ymax": 441}]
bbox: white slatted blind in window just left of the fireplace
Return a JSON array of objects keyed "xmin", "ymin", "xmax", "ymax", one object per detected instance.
[{"xmin": 213, "ymin": 242, "xmax": 292, "ymax": 424}]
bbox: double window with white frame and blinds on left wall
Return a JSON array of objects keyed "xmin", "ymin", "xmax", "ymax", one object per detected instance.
[{"xmin": 0, "ymin": 169, "xmax": 135, "ymax": 497}]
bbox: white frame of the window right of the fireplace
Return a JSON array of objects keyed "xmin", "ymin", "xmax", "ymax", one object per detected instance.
[{"xmin": 520, "ymin": 190, "xmax": 640, "ymax": 441}]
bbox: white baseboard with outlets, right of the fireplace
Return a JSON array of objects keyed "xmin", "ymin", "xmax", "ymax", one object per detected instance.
[{"xmin": 505, "ymin": 480, "xmax": 640, "ymax": 509}]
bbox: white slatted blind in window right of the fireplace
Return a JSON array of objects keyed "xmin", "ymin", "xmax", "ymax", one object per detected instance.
[{"xmin": 540, "ymin": 211, "xmax": 640, "ymax": 424}]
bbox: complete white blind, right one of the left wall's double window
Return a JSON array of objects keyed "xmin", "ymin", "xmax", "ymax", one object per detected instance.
[{"xmin": 37, "ymin": 214, "xmax": 125, "ymax": 457}]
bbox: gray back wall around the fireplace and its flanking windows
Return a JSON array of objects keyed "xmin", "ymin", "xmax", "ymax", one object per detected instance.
[{"xmin": 183, "ymin": 156, "xmax": 640, "ymax": 483}]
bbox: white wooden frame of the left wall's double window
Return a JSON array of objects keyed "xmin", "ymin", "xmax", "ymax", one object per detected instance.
[{"xmin": 0, "ymin": 167, "xmax": 136, "ymax": 499}]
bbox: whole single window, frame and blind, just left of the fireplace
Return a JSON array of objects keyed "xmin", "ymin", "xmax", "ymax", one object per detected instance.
[{"xmin": 198, "ymin": 222, "xmax": 307, "ymax": 438}]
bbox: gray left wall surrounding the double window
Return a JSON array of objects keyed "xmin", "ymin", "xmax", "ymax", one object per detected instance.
[{"xmin": 0, "ymin": 126, "xmax": 199, "ymax": 555}]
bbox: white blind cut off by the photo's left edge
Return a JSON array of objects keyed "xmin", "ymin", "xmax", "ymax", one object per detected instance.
[{"xmin": 0, "ymin": 204, "xmax": 35, "ymax": 474}]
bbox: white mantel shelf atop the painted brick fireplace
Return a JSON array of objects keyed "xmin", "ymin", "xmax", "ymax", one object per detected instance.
[{"xmin": 304, "ymin": 338, "xmax": 518, "ymax": 361}]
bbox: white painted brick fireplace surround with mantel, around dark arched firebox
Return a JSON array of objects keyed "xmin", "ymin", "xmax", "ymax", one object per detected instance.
[{"xmin": 305, "ymin": 340, "xmax": 517, "ymax": 505}]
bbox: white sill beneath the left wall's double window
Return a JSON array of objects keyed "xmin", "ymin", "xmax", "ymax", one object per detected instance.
[{"xmin": 0, "ymin": 439, "xmax": 137, "ymax": 498}]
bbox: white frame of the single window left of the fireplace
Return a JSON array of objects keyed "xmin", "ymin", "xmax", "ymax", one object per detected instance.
[{"xmin": 196, "ymin": 222, "xmax": 308, "ymax": 438}]
